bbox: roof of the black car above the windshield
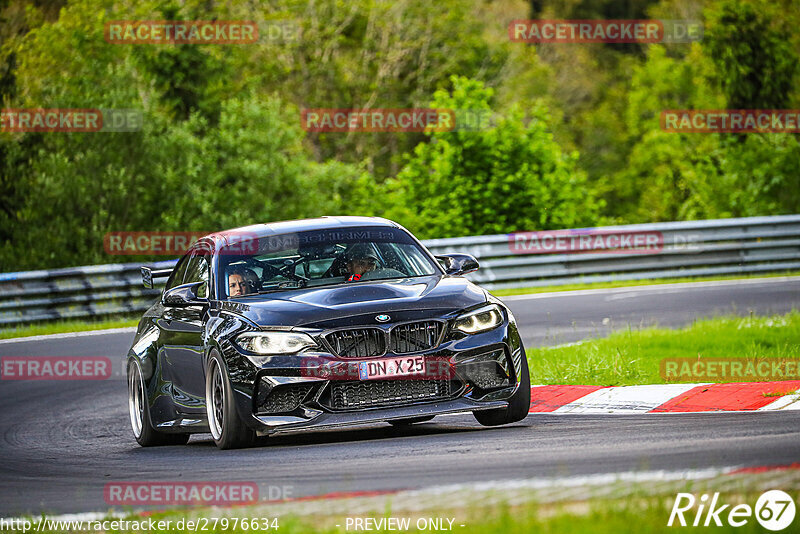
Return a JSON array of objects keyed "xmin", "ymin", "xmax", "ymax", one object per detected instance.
[{"xmin": 201, "ymin": 215, "xmax": 400, "ymax": 250}]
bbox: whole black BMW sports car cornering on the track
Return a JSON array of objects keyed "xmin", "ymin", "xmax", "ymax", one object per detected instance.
[{"xmin": 127, "ymin": 217, "xmax": 530, "ymax": 449}]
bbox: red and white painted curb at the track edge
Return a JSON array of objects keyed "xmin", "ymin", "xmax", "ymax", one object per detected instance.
[{"xmin": 530, "ymin": 380, "xmax": 800, "ymax": 414}]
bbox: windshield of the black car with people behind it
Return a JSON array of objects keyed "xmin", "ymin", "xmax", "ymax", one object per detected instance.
[{"xmin": 219, "ymin": 227, "xmax": 440, "ymax": 298}]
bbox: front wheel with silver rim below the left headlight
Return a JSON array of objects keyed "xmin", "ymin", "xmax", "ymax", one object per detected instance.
[{"xmin": 206, "ymin": 352, "xmax": 256, "ymax": 449}]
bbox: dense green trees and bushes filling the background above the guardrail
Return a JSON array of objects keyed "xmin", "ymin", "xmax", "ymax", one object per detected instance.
[{"xmin": 0, "ymin": 0, "xmax": 800, "ymax": 271}]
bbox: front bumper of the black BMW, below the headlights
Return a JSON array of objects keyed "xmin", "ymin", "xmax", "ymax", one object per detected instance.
[{"xmin": 223, "ymin": 320, "xmax": 524, "ymax": 435}]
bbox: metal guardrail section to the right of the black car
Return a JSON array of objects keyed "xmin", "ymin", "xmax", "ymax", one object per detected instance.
[{"xmin": 425, "ymin": 215, "xmax": 800, "ymax": 289}]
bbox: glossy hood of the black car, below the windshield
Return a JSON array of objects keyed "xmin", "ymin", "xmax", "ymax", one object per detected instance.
[{"xmin": 223, "ymin": 276, "xmax": 486, "ymax": 328}]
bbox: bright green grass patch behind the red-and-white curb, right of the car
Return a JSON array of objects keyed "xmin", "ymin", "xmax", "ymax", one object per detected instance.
[{"xmin": 527, "ymin": 310, "xmax": 800, "ymax": 386}]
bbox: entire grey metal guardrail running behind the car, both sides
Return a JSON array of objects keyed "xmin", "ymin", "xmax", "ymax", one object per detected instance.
[{"xmin": 0, "ymin": 215, "xmax": 800, "ymax": 326}]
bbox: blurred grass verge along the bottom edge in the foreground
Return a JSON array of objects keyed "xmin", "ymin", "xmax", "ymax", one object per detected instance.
[{"xmin": 12, "ymin": 469, "xmax": 800, "ymax": 534}]
